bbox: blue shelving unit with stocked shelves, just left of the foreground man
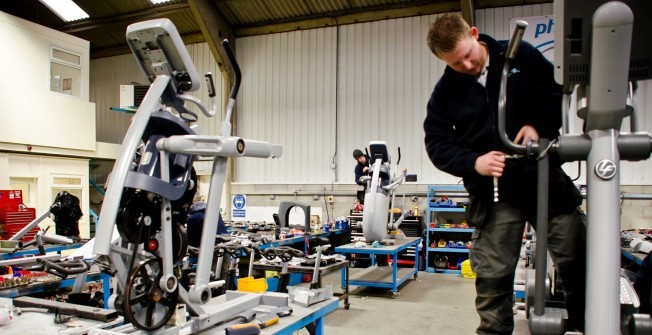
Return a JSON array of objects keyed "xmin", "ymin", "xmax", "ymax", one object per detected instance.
[{"xmin": 425, "ymin": 185, "xmax": 473, "ymax": 274}]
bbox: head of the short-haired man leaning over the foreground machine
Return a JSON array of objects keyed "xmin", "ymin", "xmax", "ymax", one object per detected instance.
[{"xmin": 427, "ymin": 13, "xmax": 486, "ymax": 76}]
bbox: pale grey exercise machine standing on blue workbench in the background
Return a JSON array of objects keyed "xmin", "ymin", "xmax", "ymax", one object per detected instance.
[{"xmin": 360, "ymin": 141, "xmax": 408, "ymax": 243}]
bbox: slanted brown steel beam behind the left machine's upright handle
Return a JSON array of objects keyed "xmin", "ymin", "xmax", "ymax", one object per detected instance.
[{"xmin": 188, "ymin": 0, "xmax": 235, "ymax": 76}]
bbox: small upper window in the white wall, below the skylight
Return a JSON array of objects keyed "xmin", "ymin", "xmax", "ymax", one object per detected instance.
[{"xmin": 50, "ymin": 46, "xmax": 82, "ymax": 97}]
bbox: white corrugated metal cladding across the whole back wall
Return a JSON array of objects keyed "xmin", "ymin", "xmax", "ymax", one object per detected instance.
[{"xmin": 91, "ymin": 1, "xmax": 652, "ymax": 185}]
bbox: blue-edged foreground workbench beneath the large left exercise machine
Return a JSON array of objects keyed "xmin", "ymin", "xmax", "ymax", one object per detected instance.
[{"xmin": 0, "ymin": 296, "xmax": 339, "ymax": 335}]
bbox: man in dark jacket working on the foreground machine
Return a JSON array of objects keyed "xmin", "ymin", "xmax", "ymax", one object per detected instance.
[{"xmin": 424, "ymin": 13, "xmax": 585, "ymax": 334}]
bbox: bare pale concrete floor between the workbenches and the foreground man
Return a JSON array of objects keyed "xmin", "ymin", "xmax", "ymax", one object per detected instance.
[{"xmin": 298, "ymin": 268, "xmax": 530, "ymax": 335}]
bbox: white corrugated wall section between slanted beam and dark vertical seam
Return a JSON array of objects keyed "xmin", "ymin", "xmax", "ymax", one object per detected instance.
[{"xmin": 235, "ymin": 28, "xmax": 337, "ymax": 183}]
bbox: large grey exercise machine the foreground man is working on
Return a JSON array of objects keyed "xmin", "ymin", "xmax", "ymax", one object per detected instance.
[{"xmin": 498, "ymin": 0, "xmax": 652, "ymax": 334}]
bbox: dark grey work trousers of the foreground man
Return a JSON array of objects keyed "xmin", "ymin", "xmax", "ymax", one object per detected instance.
[{"xmin": 470, "ymin": 202, "xmax": 586, "ymax": 334}]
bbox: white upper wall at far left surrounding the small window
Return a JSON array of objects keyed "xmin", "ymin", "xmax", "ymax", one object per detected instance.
[{"xmin": 0, "ymin": 12, "xmax": 95, "ymax": 151}]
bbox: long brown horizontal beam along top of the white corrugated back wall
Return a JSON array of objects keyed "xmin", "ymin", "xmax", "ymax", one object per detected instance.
[{"xmin": 234, "ymin": 1, "xmax": 460, "ymax": 37}]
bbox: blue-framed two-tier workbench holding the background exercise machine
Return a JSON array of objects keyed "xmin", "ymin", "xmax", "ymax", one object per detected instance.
[{"xmin": 335, "ymin": 237, "xmax": 421, "ymax": 297}]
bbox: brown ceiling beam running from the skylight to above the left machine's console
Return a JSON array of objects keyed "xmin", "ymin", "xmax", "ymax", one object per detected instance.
[{"xmin": 54, "ymin": 3, "xmax": 188, "ymax": 34}]
